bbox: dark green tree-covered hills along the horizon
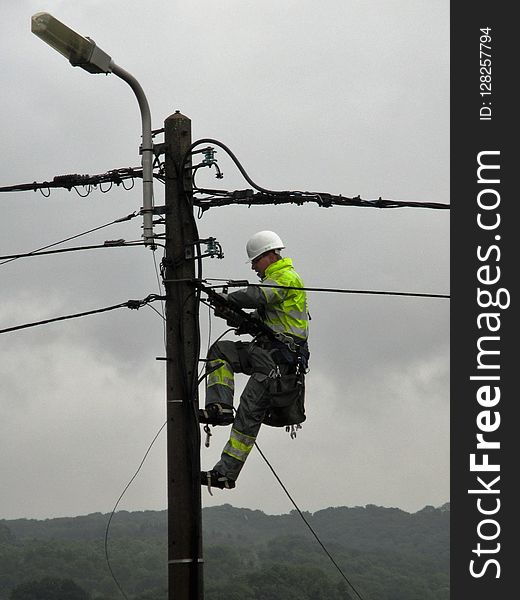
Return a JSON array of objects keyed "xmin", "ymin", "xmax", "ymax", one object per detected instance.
[{"xmin": 0, "ymin": 505, "xmax": 450, "ymax": 600}]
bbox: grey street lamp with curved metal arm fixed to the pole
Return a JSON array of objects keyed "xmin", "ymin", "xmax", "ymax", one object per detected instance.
[{"xmin": 31, "ymin": 12, "xmax": 154, "ymax": 248}]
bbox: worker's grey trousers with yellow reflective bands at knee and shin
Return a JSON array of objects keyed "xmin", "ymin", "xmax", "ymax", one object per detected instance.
[{"xmin": 206, "ymin": 341, "xmax": 289, "ymax": 480}]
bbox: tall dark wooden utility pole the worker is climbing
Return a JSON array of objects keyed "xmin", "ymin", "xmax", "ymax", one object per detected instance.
[{"xmin": 164, "ymin": 111, "xmax": 204, "ymax": 600}]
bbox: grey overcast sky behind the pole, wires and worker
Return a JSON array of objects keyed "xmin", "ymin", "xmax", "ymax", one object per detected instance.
[{"xmin": 0, "ymin": 0, "xmax": 450, "ymax": 519}]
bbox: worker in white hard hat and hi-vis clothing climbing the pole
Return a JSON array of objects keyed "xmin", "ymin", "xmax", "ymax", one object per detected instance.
[{"xmin": 199, "ymin": 231, "xmax": 309, "ymax": 489}]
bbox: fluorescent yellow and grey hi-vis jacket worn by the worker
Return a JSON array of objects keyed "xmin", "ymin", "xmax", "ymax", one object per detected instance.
[{"xmin": 227, "ymin": 258, "xmax": 309, "ymax": 342}]
